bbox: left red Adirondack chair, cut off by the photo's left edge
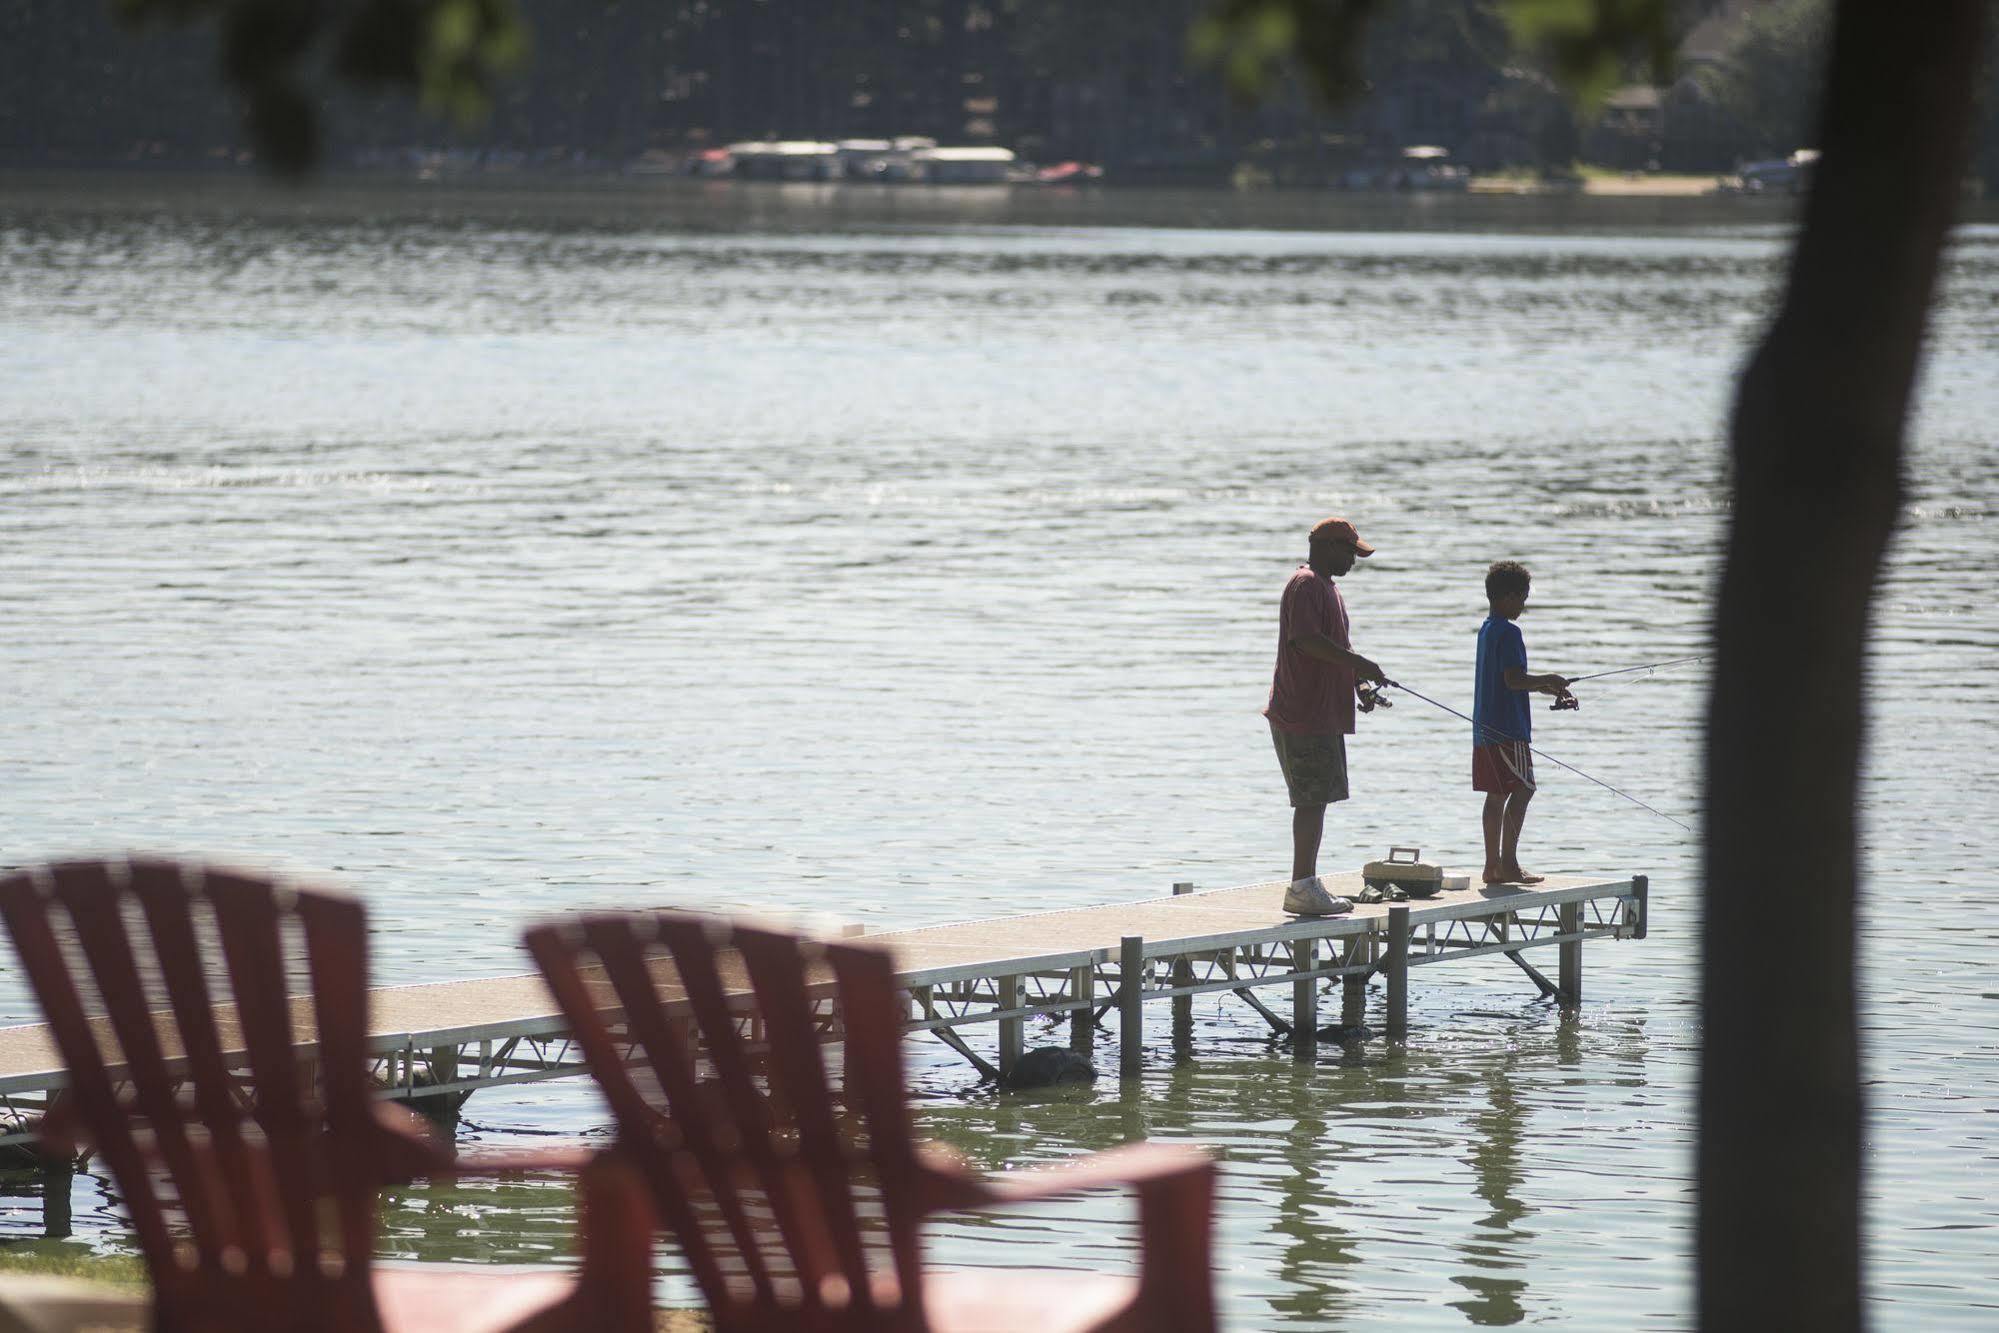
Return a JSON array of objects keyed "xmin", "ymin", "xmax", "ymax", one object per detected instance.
[{"xmin": 0, "ymin": 861, "xmax": 652, "ymax": 1333}]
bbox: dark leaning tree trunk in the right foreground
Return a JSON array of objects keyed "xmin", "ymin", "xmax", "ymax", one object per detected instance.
[{"xmin": 1699, "ymin": 0, "xmax": 1987, "ymax": 1331}]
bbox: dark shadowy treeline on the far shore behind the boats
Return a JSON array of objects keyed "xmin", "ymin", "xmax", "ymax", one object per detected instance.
[{"xmin": 0, "ymin": 0, "xmax": 1967, "ymax": 182}]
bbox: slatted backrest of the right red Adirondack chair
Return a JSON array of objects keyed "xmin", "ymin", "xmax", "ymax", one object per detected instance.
[{"xmin": 528, "ymin": 911, "xmax": 926, "ymax": 1329}]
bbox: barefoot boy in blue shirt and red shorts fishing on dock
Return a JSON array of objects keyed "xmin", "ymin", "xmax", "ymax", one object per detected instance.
[{"xmin": 1471, "ymin": 560, "xmax": 1575, "ymax": 883}]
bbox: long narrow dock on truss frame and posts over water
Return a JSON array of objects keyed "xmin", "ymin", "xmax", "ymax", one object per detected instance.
[{"xmin": 0, "ymin": 873, "xmax": 1647, "ymax": 1145}]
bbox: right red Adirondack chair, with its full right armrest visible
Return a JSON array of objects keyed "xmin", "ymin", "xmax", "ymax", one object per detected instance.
[{"xmin": 528, "ymin": 911, "xmax": 1215, "ymax": 1333}]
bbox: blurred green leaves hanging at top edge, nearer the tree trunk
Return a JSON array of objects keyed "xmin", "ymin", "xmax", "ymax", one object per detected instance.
[{"xmin": 1189, "ymin": 0, "xmax": 1701, "ymax": 106}]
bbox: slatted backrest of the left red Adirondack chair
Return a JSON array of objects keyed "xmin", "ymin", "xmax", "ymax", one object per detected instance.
[{"xmin": 0, "ymin": 859, "xmax": 374, "ymax": 1327}]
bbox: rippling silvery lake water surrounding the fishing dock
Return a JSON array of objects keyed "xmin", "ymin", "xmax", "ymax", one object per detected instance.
[{"xmin": 0, "ymin": 180, "xmax": 1999, "ymax": 1329}]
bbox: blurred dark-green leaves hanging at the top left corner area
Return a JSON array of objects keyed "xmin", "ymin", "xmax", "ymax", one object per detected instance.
[{"xmin": 112, "ymin": 0, "xmax": 528, "ymax": 174}]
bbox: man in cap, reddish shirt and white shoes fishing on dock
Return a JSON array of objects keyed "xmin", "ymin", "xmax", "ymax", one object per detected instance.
[{"xmin": 1263, "ymin": 518, "xmax": 1387, "ymax": 917}]
